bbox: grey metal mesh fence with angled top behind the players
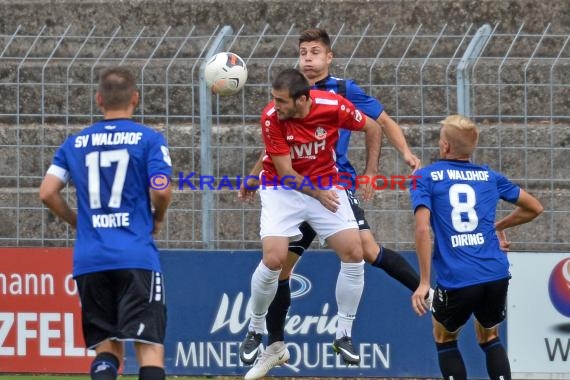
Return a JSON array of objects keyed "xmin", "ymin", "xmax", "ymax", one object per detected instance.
[{"xmin": 0, "ymin": 25, "xmax": 570, "ymax": 251}]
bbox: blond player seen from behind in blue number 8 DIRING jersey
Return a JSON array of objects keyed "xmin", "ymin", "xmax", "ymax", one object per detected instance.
[{"xmin": 410, "ymin": 115, "xmax": 543, "ymax": 380}]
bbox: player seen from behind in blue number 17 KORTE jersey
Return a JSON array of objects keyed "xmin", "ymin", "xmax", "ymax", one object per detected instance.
[{"xmin": 40, "ymin": 67, "xmax": 172, "ymax": 380}]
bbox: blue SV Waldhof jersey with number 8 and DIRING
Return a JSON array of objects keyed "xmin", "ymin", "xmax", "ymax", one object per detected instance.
[{"xmin": 410, "ymin": 160, "xmax": 520, "ymax": 289}]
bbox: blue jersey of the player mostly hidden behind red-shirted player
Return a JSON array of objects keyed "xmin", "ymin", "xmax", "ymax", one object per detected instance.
[{"xmin": 313, "ymin": 75, "xmax": 384, "ymax": 185}]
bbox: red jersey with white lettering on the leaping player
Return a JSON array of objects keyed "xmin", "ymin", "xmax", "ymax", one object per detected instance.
[{"xmin": 261, "ymin": 90, "xmax": 366, "ymax": 186}]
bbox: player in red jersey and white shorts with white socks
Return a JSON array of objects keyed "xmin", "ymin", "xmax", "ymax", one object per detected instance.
[{"xmin": 237, "ymin": 69, "xmax": 381, "ymax": 379}]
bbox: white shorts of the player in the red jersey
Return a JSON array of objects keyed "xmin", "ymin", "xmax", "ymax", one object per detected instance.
[{"xmin": 259, "ymin": 187, "xmax": 358, "ymax": 243}]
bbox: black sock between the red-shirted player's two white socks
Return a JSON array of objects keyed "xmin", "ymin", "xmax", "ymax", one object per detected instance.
[{"xmin": 265, "ymin": 279, "xmax": 291, "ymax": 346}]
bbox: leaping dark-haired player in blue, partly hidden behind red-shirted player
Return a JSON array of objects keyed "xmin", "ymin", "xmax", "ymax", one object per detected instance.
[{"xmin": 239, "ymin": 28, "xmax": 432, "ymax": 379}]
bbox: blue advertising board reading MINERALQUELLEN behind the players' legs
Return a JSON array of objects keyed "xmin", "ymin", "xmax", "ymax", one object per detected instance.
[{"xmin": 125, "ymin": 251, "xmax": 487, "ymax": 378}]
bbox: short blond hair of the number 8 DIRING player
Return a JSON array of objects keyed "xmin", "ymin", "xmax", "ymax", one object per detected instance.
[{"xmin": 440, "ymin": 115, "xmax": 479, "ymax": 156}]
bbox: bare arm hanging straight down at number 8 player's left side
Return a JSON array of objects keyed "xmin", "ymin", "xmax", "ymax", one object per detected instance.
[{"xmin": 412, "ymin": 206, "xmax": 432, "ymax": 316}]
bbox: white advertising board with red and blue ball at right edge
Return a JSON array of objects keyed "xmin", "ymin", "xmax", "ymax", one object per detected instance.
[{"xmin": 507, "ymin": 252, "xmax": 570, "ymax": 379}]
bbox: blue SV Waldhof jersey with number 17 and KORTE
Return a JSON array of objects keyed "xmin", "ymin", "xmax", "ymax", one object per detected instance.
[{"xmin": 48, "ymin": 119, "xmax": 172, "ymax": 276}]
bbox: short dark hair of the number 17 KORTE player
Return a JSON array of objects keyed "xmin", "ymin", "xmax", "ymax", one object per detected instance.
[{"xmin": 97, "ymin": 66, "xmax": 137, "ymax": 110}]
